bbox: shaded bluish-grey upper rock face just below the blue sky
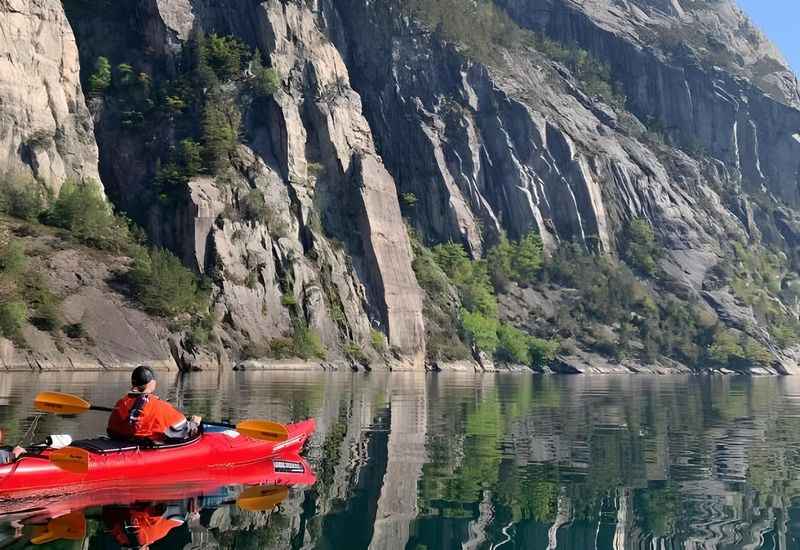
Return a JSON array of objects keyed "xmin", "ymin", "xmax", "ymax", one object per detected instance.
[{"xmin": 499, "ymin": 0, "xmax": 800, "ymax": 206}]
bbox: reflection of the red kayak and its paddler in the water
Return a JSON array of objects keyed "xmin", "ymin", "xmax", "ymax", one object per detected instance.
[{"xmin": 0, "ymin": 454, "xmax": 316, "ymax": 549}]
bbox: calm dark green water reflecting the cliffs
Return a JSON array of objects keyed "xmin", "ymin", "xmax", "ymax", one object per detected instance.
[{"xmin": 0, "ymin": 373, "xmax": 800, "ymax": 550}]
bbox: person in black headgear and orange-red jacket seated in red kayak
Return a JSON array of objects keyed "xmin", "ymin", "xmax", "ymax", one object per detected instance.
[{"xmin": 107, "ymin": 365, "xmax": 202, "ymax": 443}]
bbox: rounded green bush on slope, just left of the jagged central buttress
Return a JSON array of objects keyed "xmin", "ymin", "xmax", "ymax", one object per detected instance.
[{"xmin": 126, "ymin": 248, "xmax": 208, "ymax": 317}]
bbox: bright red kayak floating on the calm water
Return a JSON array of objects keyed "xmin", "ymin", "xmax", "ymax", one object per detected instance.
[{"xmin": 0, "ymin": 419, "xmax": 316, "ymax": 499}]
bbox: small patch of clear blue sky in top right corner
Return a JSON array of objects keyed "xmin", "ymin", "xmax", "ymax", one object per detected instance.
[{"xmin": 737, "ymin": 0, "xmax": 800, "ymax": 74}]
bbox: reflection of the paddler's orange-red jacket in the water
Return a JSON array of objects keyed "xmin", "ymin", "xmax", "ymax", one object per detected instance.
[{"xmin": 103, "ymin": 503, "xmax": 193, "ymax": 550}]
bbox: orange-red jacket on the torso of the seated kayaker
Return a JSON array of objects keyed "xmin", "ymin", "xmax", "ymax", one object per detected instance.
[{"xmin": 108, "ymin": 393, "xmax": 186, "ymax": 441}]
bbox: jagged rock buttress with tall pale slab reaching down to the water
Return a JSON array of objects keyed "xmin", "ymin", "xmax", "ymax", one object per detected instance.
[{"xmin": 86, "ymin": 0, "xmax": 425, "ymax": 368}]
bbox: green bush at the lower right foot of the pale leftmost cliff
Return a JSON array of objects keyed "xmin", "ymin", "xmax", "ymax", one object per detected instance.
[{"xmin": 45, "ymin": 180, "xmax": 133, "ymax": 253}]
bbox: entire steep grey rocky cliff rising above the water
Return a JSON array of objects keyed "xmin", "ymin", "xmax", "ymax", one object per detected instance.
[{"xmin": 0, "ymin": 0, "xmax": 800, "ymax": 372}]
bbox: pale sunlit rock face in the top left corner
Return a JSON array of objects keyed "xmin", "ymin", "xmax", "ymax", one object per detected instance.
[{"xmin": 0, "ymin": 0, "xmax": 100, "ymax": 191}]
